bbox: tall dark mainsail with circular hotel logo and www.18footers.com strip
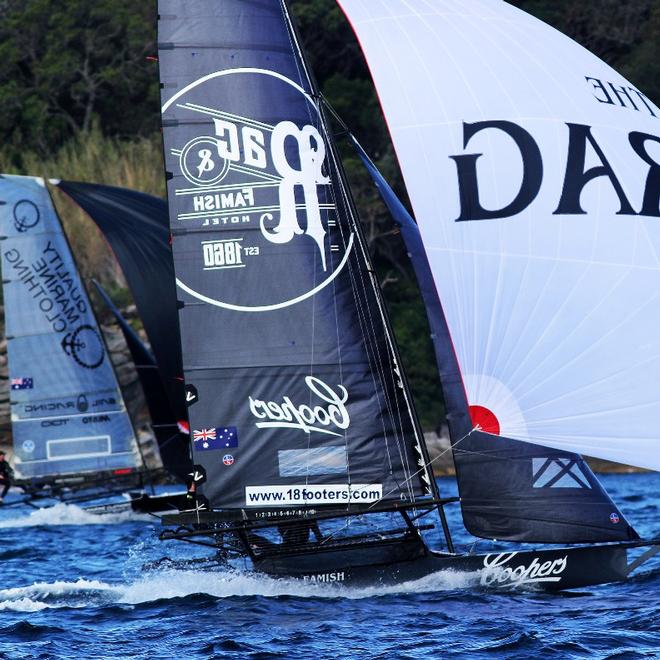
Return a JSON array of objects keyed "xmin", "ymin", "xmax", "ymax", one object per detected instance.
[{"xmin": 159, "ymin": 0, "xmax": 433, "ymax": 512}]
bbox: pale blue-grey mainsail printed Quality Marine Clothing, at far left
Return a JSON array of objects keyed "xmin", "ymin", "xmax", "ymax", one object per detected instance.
[{"xmin": 0, "ymin": 175, "xmax": 140, "ymax": 479}]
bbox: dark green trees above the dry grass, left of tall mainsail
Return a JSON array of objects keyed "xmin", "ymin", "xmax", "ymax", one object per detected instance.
[{"xmin": 0, "ymin": 0, "xmax": 158, "ymax": 164}]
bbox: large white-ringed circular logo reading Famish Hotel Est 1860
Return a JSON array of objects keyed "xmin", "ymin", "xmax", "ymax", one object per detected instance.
[{"xmin": 163, "ymin": 69, "xmax": 353, "ymax": 312}]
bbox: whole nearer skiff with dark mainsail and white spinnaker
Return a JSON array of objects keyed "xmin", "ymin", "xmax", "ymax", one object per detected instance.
[{"xmin": 146, "ymin": 0, "xmax": 660, "ymax": 590}]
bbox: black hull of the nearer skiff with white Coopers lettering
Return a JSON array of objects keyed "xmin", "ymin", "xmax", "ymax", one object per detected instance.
[{"xmin": 253, "ymin": 543, "xmax": 629, "ymax": 591}]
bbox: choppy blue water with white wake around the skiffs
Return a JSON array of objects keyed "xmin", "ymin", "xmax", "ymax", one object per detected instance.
[{"xmin": 0, "ymin": 473, "xmax": 660, "ymax": 660}]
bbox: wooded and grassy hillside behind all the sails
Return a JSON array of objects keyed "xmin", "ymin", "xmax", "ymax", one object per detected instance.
[{"xmin": 0, "ymin": 0, "xmax": 660, "ymax": 428}]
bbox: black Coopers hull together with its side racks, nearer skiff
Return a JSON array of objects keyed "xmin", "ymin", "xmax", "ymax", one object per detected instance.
[{"xmin": 160, "ymin": 506, "xmax": 660, "ymax": 592}]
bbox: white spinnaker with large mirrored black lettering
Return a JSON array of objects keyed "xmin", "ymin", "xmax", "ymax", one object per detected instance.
[{"xmin": 338, "ymin": 0, "xmax": 660, "ymax": 469}]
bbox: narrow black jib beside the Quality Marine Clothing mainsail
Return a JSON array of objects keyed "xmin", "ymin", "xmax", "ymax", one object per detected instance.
[{"xmin": 94, "ymin": 281, "xmax": 192, "ymax": 482}]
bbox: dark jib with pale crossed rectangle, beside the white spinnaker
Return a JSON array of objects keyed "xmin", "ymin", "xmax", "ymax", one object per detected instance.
[{"xmin": 352, "ymin": 138, "xmax": 638, "ymax": 543}]
